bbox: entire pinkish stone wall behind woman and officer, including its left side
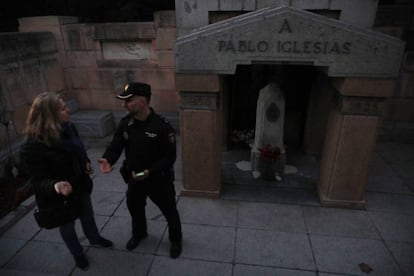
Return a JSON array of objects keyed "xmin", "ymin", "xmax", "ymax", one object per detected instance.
[{"xmin": 0, "ymin": 11, "xmax": 178, "ymax": 172}]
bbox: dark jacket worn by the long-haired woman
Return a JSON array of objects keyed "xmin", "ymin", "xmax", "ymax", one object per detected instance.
[{"xmin": 20, "ymin": 122, "xmax": 92, "ymax": 209}]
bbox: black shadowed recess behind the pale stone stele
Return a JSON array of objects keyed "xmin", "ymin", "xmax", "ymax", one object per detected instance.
[{"xmin": 227, "ymin": 64, "xmax": 316, "ymax": 150}]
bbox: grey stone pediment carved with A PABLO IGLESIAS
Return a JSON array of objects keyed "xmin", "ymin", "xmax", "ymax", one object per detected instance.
[{"xmin": 175, "ymin": 7, "xmax": 405, "ymax": 78}]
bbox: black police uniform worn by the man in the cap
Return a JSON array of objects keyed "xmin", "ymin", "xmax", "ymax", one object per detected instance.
[{"xmin": 102, "ymin": 82, "xmax": 182, "ymax": 256}]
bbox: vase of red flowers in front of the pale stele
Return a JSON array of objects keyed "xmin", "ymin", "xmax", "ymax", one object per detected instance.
[{"xmin": 258, "ymin": 144, "xmax": 282, "ymax": 180}]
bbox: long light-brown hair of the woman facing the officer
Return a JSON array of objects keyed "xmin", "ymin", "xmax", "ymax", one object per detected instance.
[{"xmin": 24, "ymin": 92, "xmax": 63, "ymax": 145}]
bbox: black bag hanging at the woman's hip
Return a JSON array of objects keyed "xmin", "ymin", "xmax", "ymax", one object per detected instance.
[{"xmin": 34, "ymin": 201, "xmax": 79, "ymax": 229}]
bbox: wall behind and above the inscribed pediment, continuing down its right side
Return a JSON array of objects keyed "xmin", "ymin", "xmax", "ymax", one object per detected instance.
[{"xmin": 175, "ymin": 0, "xmax": 414, "ymax": 142}]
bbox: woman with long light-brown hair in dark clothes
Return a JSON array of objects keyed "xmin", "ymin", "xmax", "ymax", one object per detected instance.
[{"xmin": 20, "ymin": 92, "xmax": 112, "ymax": 269}]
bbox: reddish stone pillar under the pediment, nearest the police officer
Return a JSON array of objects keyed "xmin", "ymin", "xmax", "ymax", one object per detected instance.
[{"xmin": 176, "ymin": 74, "xmax": 222, "ymax": 197}]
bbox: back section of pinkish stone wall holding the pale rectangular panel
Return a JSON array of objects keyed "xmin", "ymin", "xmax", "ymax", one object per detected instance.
[{"xmin": 19, "ymin": 11, "xmax": 178, "ymax": 113}]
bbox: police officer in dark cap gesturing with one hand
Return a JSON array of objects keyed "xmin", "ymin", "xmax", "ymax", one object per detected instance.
[{"xmin": 98, "ymin": 82, "xmax": 182, "ymax": 258}]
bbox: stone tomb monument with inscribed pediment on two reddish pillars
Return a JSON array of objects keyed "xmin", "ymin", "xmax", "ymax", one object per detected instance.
[{"xmin": 175, "ymin": 7, "xmax": 404, "ymax": 208}]
